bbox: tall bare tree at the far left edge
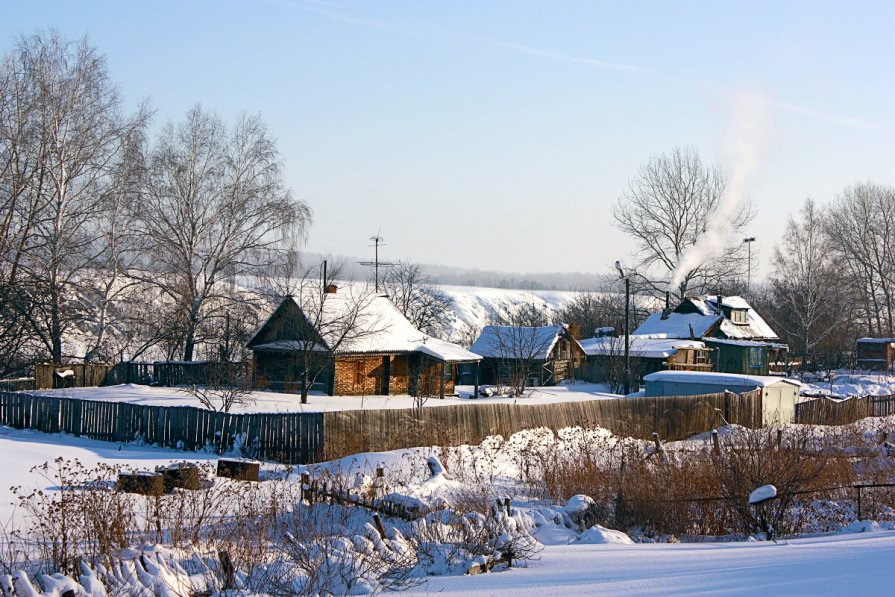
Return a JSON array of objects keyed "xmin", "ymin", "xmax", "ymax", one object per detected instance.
[{"xmin": 0, "ymin": 32, "xmax": 148, "ymax": 361}]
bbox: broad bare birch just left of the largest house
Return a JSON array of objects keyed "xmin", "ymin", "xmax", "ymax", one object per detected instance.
[{"xmin": 136, "ymin": 107, "xmax": 311, "ymax": 361}]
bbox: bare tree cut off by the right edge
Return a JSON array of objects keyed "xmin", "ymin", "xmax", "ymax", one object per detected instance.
[{"xmin": 827, "ymin": 182, "xmax": 895, "ymax": 336}]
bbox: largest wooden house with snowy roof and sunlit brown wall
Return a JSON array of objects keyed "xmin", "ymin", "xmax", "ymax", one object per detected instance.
[{"xmin": 248, "ymin": 285, "xmax": 481, "ymax": 397}]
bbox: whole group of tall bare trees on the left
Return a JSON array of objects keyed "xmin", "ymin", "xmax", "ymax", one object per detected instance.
[{"xmin": 0, "ymin": 31, "xmax": 311, "ymax": 375}]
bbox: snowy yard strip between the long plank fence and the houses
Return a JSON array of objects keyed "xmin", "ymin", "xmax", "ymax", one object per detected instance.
[{"xmin": 31, "ymin": 384, "xmax": 619, "ymax": 413}]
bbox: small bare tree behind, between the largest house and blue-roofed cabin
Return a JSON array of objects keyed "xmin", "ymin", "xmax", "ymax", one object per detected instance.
[{"xmin": 383, "ymin": 261, "xmax": 453, "ymax": 339}]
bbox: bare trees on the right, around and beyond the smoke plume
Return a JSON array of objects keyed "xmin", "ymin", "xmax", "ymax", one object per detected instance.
[{"xmin": 613, "ymin": 148, "xmax": 895, "ymax": 369}]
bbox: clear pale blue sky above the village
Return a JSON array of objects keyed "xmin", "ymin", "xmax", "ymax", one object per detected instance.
[{"xmin": 0, "ymin": 0, "xmax": 895, "ymax": 280}]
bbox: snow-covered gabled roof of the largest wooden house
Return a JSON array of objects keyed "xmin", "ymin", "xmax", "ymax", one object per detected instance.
[{"xmin": 248, "ymin": 292, "xmax": 481, "ymax": 362}]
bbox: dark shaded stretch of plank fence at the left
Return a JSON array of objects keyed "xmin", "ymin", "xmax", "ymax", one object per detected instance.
[{"xmin": 0, "ymin": 392, "xmax": 323, "ymax": 464}]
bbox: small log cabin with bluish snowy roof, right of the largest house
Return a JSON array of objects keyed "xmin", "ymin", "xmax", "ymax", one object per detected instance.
[{"xmin": 469, "ymin": 324, "xmax": 585, "ymax": 386}]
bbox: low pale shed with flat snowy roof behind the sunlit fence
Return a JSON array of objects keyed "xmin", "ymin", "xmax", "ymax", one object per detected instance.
[{"xmin": 643, "ymin": 371, "xmax": 802, "ymax": 425}]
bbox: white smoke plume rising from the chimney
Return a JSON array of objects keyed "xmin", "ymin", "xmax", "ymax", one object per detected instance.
[{"xmin": 668, "ymin": 90, "xmax": 770, "ymax": 291}]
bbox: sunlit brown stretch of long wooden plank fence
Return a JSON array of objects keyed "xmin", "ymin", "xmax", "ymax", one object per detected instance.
[{"xmin": 323, "ymin": 392, "xmax": 762, "ymax": 458}]
